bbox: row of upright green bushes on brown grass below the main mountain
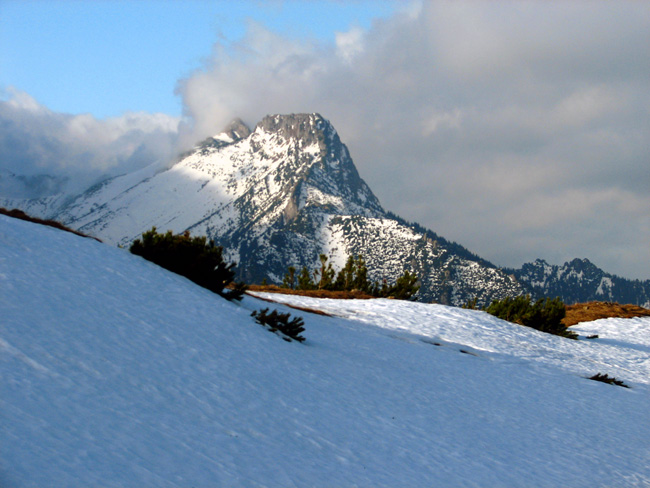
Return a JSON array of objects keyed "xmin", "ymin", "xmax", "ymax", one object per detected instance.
[{"xmin": 282, "ymin": 254, "xmax": 420, "ymax": 300}]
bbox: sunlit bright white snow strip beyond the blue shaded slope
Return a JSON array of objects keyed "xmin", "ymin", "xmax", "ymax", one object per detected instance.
[{"xmin": 254, "ymin": 293, "xmax": 650, "ymax": 388}]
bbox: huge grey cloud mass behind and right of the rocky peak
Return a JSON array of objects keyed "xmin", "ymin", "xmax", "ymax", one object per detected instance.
[{"xmin": 178, "ymin": 2, "xmax": 650, "ymax": 279}]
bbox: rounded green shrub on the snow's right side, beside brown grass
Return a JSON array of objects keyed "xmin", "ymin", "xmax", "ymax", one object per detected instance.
[{"xmin": 485, "ymin": 295, "xmax": 578, "ymax": 339}]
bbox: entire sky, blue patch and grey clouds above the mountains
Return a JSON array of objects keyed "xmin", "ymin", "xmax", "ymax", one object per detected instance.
[{"xmin": 0, "ymin": 0, "xmax": 650, "ymax": 279}]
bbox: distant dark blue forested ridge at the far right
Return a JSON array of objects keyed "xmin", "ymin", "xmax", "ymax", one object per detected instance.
[{"xmin": 511, "ymin": 259, "xmax": 650, "ymax": 308}]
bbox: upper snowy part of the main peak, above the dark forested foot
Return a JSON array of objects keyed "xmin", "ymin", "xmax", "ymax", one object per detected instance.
[{"xmin": 58, "ymin": 114, "xmax": 383, "ymax": 248}]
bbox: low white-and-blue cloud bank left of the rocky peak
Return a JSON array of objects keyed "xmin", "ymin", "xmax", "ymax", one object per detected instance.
[{"xmin": 0, "ymin": 90, "xmax": 179, "ymax": 196}]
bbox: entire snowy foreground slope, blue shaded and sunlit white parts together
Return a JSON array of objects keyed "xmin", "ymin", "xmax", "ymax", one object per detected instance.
[{"xmin": 0, "ymin": 216, "xmax": 650, "ymax": 487}]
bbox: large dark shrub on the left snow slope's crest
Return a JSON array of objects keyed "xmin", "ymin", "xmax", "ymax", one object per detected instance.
[{"xmin": 129, "ymin": 227, "xmax": 246, "ymax": 300}]
